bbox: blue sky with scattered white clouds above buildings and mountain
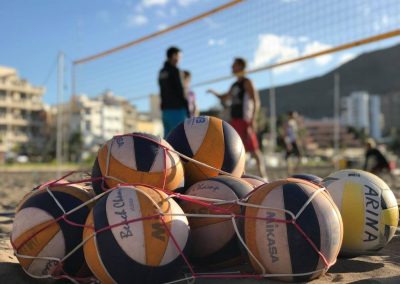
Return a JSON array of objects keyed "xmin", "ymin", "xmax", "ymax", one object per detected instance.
[{"xmin": 0, "ymin": 0, "xmax": 400, "ymax": 111}]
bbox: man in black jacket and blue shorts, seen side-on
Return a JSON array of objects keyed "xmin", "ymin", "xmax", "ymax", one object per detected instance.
[{"xmin": 158, "ymin": 46, "xmax": 189, "ymax": 137}]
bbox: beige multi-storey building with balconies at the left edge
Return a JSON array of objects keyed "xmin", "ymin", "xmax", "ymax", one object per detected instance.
[{"xmin": 0, "ymin": 66, "xmax": 45, "ymax": 161}]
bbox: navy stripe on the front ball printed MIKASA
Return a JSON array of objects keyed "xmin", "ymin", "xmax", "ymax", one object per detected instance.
[{"xmin": 283, "ymin": 183, "xmax": 321, "ymax": 282}]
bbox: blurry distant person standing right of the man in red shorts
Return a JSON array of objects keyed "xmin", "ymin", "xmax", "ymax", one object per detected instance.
[{"xmin": 284, "ymin": 111, "xmax": 301, "ymax": 175}]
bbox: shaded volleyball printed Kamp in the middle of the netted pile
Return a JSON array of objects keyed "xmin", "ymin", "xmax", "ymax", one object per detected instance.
[{"xmin": 181, "ymin": 176, "xmax": 253, "ymax": 267}]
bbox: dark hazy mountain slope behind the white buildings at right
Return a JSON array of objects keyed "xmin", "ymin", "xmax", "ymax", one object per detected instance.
[{"xmin": 260, "ymin": 42, "xmax": 400, "ymax": 118}]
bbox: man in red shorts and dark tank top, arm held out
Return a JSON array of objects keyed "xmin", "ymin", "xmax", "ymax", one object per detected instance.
[{"xmin": 208, "ymin": 58, "xmax": 267, "ymax": 178}]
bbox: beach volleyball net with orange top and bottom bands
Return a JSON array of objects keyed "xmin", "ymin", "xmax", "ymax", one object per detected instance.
[{"xmin": 72, "ymin": 0, "xmax": 400, "ymax": 114}]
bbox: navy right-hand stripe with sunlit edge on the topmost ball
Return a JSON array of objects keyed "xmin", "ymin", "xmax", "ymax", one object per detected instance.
[{"xmin": 221, "ymin": 121, "xmax": 244, "ymax": 176}]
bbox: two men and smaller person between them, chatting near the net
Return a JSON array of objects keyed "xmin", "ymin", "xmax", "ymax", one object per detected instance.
[{"xmin": 158, "ymin": 47, "xmax": 267, "ymax": 177}]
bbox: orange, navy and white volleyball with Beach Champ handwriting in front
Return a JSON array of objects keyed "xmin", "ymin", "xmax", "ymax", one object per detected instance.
[{"xmin": 83, "ymin": 186, "xmax": 189, "ymax": 283}]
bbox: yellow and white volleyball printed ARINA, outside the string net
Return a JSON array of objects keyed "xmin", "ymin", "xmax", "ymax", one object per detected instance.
[{"xmin": 323, "ymin": 170, "xmax": 399, "ymax": 256}]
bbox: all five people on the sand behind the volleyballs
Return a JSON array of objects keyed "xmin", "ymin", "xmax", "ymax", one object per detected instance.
[{"xmin": 158, "ymin": 47, "xmax": 389, "ymax": 180}]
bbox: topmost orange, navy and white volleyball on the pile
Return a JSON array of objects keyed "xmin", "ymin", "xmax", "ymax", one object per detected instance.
[{"xmin": 167, "ymin": 116, "xmax": 245, "ymax": 186}]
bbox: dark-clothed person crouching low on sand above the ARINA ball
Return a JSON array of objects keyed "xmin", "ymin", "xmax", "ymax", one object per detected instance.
[{"xmin": 363, "ymin": 138, "xmax": 391, "ymax": 176}]
